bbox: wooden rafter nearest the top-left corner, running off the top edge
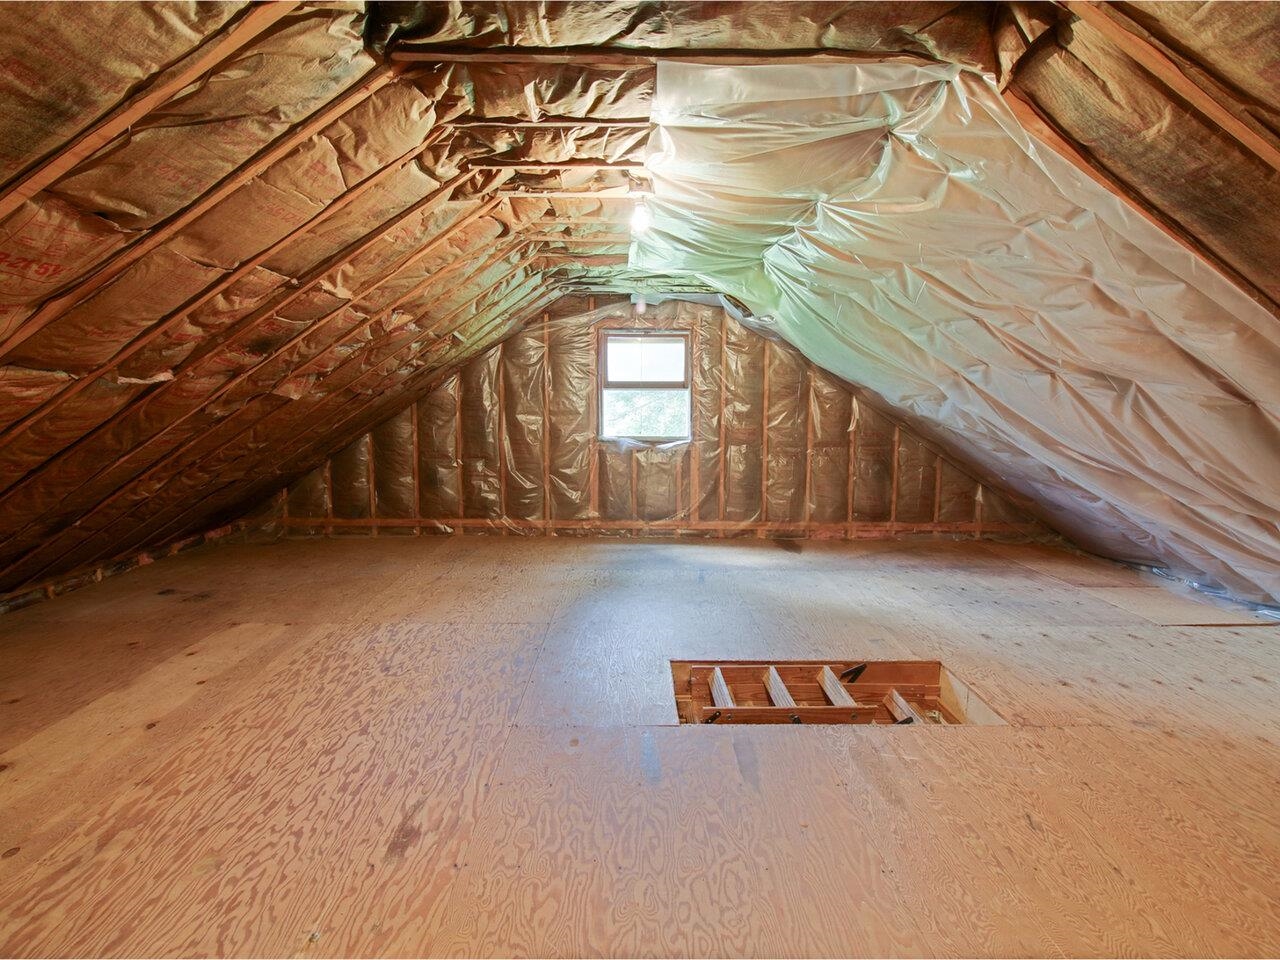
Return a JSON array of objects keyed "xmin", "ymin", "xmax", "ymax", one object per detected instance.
[{"xmin": 0, "ymin": 0, "xmax": 298, "ymax": 220}]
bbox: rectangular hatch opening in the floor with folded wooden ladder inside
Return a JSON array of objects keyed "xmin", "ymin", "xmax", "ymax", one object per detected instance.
[{"xmin": 671, "ymin": 660, "xmax": 1005, "ymax": 726}]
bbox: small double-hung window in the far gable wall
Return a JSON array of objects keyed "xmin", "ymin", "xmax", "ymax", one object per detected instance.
[{"xmin": 600, "ymin": 330, "xmax": 691, "ymax": 440}]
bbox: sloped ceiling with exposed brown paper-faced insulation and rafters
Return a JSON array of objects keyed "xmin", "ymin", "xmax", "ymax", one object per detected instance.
[{"xmin": 0, "ymin": 3, "xmax": 1280, "ymax": 599}]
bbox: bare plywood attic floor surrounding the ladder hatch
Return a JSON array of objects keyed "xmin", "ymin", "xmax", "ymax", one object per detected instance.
[{"xmin": 0, "ymin": 536, "xmax": 1280, "ymax": 956}]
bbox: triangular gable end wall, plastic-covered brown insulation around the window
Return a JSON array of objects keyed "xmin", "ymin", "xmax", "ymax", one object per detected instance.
[{"xmin": 275, "ymin": 297, "xmax": 1048, "ymax": 538}]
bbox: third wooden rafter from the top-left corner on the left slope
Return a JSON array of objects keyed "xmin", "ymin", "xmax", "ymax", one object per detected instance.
[{"xmin": 0, "ymin": 129, "xmax": 455, "ymax": 455}]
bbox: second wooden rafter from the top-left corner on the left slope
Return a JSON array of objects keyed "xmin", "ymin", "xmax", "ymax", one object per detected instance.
[{"xmin": 0, "ymin": 67, "xmax": 398, "ymax": 357}]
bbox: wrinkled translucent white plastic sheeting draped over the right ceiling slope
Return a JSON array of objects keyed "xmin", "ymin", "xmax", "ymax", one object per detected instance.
[{"xmin": 631, "ymin": 61, "xmax": 1280, "ymax": 600}]
